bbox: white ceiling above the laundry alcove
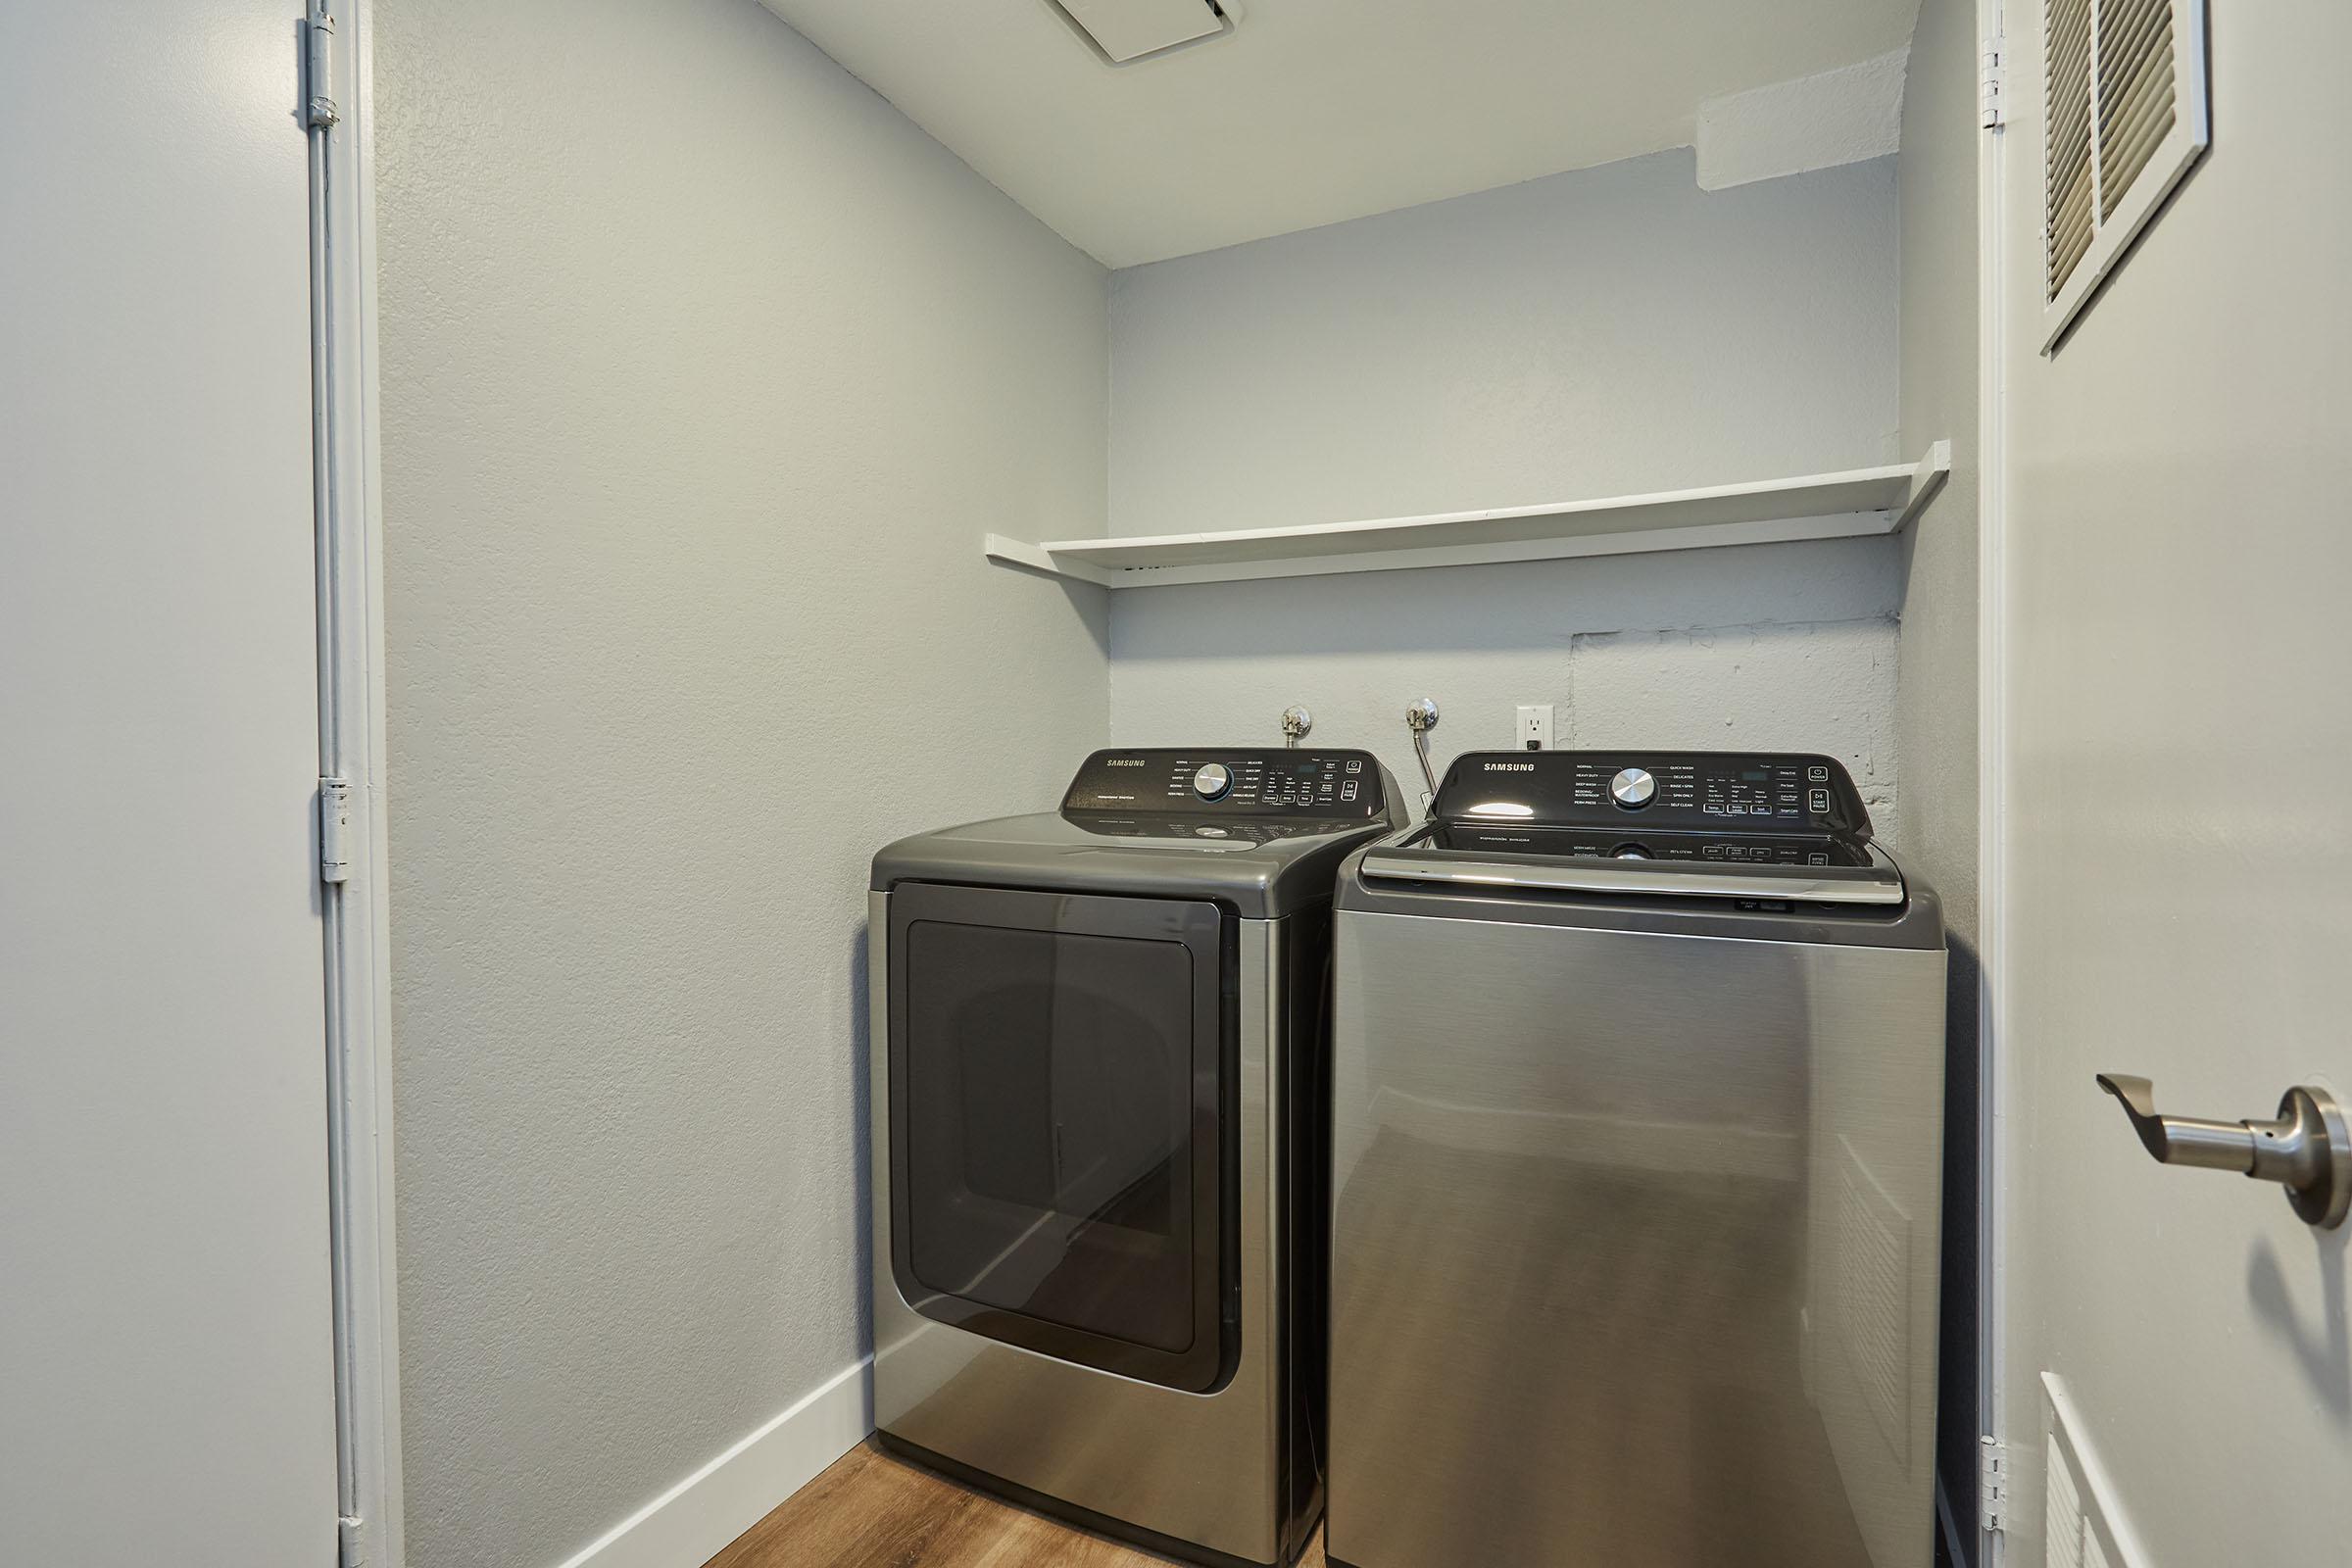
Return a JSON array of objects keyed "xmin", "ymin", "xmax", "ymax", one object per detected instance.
[{"xmin": 764, "ymin": 0, "xmax": 1917, "ymax": 268}]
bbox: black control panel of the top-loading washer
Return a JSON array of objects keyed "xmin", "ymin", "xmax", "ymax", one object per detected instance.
[{"xmin": 1435, "ymin": 753, "xmax": 1870, "ymax": 841}]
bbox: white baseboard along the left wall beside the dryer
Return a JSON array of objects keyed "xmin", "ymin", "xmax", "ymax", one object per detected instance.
[{"xmin": 563, "ymin": 1356, "xmax": 875, "ymax": 1568}]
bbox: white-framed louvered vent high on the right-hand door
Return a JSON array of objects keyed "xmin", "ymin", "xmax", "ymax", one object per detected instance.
[{"xmin": 2041, "ymin": 0, "xmax": 2213, "ymax": 350}]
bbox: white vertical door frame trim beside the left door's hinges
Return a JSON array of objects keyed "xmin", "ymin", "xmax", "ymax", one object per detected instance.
[{"xmin": 306, "ymin": 0, "xmax": 405, "ymax": 1568}]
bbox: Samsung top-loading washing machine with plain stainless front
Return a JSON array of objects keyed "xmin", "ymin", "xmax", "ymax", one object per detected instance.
[{"xmin": 1324, "ymin": 753, "xmax": 1945, "ymax": 1568}]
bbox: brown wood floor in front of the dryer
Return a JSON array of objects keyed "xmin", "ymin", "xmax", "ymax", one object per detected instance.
[{"xmin": 706, "ymin": 1444, "xmax": 1324, "ymax": 1568}]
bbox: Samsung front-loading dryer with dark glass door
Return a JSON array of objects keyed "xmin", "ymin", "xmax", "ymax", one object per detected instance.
[{"xmin": 868, "ymin": 748, "xmax": 1401, "ymax": 1568}]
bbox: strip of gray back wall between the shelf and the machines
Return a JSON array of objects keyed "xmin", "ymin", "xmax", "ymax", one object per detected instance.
[{"xmin": 1110, "ymin": 541, "xmax": 1900, "ymax": 827}]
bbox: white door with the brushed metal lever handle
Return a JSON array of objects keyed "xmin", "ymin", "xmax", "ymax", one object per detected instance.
[{"xmin": 1999, "ymin": 0, "xmax": 2352, "ymax": 1568}]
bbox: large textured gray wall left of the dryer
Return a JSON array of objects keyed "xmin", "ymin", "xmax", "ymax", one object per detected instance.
[{"xmin": 376, "ymin": 0, "xmax": 1105, "ymax": 1568}]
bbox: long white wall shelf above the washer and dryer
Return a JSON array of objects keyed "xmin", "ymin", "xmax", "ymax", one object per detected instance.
[{"xmin": 988, "ymin": 442, "xmax": 1952, "ymax": 588}]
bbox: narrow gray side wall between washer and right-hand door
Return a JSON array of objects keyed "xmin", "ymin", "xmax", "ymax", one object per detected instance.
[{"xmin": 1893, "ymin": 0, "xmax": 1985, "ymax": 1556}]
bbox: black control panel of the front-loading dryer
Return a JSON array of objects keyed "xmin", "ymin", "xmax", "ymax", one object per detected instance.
[{"xmin": 1060, "ymin": 748, "xmax": 1388, "ymax": 823}]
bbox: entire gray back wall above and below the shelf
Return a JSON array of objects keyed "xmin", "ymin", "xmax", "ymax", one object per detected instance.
[{"xmin": 1110, "ymin": 151, "xmax": 1924, "ymax": 832}]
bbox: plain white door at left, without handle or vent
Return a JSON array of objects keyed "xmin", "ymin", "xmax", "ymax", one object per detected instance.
[{"xmin": 0, "ymin": 0, "xmax": 336, "ymax": 1568}]
